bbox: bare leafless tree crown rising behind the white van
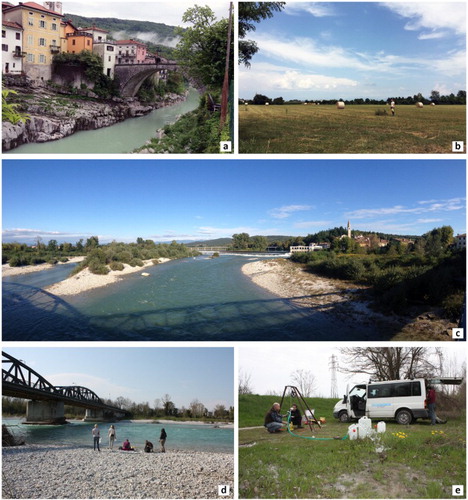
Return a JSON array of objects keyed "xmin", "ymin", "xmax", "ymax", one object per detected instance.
[{"xmin": 340, "ymin": 347, "xmax": 441, "ymax": 380}]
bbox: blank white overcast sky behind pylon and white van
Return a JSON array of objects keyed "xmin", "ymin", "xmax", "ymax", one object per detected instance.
[{"xmin": 238, "ymin": 342, "xmax": 466, "ymax": 403}]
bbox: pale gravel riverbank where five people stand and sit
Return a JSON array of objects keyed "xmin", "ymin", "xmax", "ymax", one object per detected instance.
[{"xmin": 2, "ymin": 445, "xmax": 234, "ymax": 498}]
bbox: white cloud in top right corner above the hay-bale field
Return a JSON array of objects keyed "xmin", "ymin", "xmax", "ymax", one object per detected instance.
[{"xmin": 382, "ymin": 2, "xmax": 466, "ymax": 35}]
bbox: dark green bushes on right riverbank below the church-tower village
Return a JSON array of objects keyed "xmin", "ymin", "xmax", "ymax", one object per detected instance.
[{"xmin": 291, "ymin": 226, "xmax": 466, "ymax": 321}]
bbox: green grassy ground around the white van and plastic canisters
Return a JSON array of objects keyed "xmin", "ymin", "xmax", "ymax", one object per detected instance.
[{"xmin": 239, "ymin": 395, "xmax": 466, "ymax": 498}]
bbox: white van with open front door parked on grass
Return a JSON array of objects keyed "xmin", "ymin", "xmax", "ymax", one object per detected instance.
[{"xmin": 333, "ymin": 377, "xmax": 463, "ymax": 424}]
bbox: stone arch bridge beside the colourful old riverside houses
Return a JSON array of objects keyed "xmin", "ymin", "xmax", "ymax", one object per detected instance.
[{"xmin": 114, "ymin": 58, "xmax": 178, "ymax": 97}]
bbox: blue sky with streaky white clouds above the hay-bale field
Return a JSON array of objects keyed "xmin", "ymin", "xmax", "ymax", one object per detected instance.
[{"xmin": 239, "ymin": 2, "xmax": 466, "ymax": 100}]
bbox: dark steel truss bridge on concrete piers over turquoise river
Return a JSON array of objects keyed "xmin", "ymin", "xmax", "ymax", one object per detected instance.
[{"xmin": 2, "ymin": 352, "xmax": 129, "ymax": 424}]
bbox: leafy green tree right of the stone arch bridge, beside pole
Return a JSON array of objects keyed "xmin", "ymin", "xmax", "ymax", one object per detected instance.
[{"xmin": 174, "ymin": 5, "xmax": 232, "ymax": 89}]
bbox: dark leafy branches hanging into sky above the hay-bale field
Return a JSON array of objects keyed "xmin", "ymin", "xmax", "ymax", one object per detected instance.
[{"xmin": 238, "ymin": 2, "xmax": 286, "ymax": 67}]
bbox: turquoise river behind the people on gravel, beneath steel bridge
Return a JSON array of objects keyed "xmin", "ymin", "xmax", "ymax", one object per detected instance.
[{"xmin": 2, "ymin": 418, "xmax": 234, "ymax": 453}]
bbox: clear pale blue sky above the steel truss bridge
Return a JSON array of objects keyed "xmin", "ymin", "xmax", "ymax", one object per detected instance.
[{"xmin": 3, "ymin": 346, "xmax": 237, "ymax": 410}]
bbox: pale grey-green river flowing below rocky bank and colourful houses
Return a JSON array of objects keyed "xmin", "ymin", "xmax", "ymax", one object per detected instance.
[{"xmin": 7, "ymin": 88, "xmax": 200, "ymax": 154}]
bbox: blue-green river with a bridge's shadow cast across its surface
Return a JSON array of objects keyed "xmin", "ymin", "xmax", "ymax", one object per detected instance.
[{"xmin": 3, "ymin": 255, "xmax": 376, "ymax": 341}]
